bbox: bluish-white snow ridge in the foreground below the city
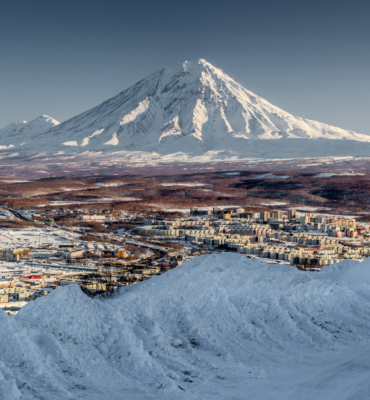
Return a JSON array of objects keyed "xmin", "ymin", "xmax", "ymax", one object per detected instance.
[{"xmin": 0, "ymin": 254, "xmax": 370, "ymax": 400}]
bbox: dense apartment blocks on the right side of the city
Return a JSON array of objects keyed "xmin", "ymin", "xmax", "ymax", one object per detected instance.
[{"xmin": 137, "ymin": 207, "xmax": 370, "ymax": 269}]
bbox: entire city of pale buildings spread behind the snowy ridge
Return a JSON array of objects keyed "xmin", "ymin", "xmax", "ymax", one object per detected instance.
[{"xmin": 0, "ymin": 207, "xmax": 370, "ymax": 314}]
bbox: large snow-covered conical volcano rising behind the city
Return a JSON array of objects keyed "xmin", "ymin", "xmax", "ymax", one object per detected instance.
[{"xmin": 0, "ymin": 59, "xmax": 370, "ymax": 161}]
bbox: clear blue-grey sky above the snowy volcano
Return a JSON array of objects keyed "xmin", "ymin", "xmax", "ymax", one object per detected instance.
[{"xmin": 0, "ymin": 0, "xmax": 370, "ymax": 134}]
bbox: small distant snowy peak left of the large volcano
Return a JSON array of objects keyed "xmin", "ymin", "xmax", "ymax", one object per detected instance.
[{"xmin": 0, "ymin": 115, "xmax": 59, "ymax": 149}]
